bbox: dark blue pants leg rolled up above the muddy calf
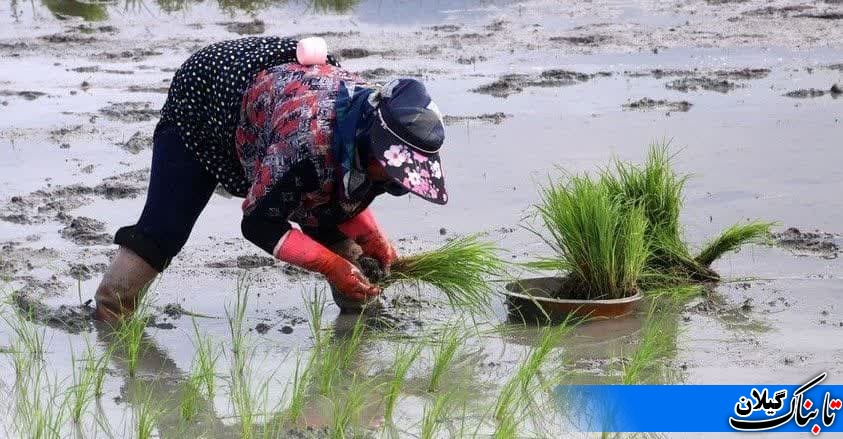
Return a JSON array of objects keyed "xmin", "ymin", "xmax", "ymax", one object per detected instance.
[{"xmin": 114, "ymin": 122, "xmax": 217, "ymax": 271}]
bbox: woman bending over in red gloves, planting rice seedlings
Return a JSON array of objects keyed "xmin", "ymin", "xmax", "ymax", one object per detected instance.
[{"xmin": 96, "ymin": 38, "xmax": 447, "ymax": 320}]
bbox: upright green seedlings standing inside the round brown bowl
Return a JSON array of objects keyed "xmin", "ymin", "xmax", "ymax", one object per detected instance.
[{"xmin": 528, "ymin": 176, "xmax": 650, "ymax": 300}]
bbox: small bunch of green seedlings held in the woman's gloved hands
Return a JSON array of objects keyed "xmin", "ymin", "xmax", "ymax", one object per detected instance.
[{"xmin": 378, "ymin": 235, "xmax": 504, "ymax": 309}]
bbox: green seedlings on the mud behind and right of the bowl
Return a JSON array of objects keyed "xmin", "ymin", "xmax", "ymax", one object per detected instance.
[{"xmin": 602, "ymin": 144, "xmax": 773, "ymax": 285}]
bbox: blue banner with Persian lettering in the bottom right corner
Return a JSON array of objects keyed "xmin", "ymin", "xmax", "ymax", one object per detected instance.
[{"xmin": 554, "ymin": 373, "xmax": 843, "ymax": 435}]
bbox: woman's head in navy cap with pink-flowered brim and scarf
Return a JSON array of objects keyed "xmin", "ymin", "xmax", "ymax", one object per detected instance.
[{"xmin": 361, "ymin": 79, "xmax": 448, "ymax": 204}]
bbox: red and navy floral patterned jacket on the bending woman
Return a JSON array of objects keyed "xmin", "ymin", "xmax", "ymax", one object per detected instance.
[{"xmin": 235, "ymin": 63, "xmax": 383, "ymax": 253}]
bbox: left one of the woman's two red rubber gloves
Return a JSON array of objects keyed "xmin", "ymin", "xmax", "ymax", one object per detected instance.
[{"xmin": 274, "ymin": 229, "xmax": 381, "ymax": 301}]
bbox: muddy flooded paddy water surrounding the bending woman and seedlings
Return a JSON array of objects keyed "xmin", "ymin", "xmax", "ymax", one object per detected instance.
[{"xmin": 0, "ymin": 0, "xmax": 843, "ymax": 437}]
